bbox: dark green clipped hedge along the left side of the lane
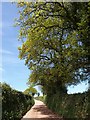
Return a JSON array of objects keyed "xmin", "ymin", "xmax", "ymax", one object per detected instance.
[{"xmin": 2, "ymin": 83, "xmax": 34, "ymax": 120}]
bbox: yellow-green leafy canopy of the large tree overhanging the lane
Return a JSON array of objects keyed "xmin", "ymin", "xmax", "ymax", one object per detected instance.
[{"xmin": 17, "ymin": 2, "xmax": 90, "ymax": 94}]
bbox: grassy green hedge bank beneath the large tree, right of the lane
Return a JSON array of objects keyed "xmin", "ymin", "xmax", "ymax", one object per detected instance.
[{"xmin": 45, "ymin": 92, "xmax": 90, "ymax": 120}]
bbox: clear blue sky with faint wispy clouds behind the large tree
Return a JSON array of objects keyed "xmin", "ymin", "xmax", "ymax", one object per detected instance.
[{"xmin": 0, "ymin": 2, "xmax": 87, "ymax": 93}]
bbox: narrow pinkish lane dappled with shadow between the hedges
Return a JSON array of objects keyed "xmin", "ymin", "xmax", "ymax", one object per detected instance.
[{"xmin": 21, "ymin": 100, "xmax": 62, "ymax": 120}]
